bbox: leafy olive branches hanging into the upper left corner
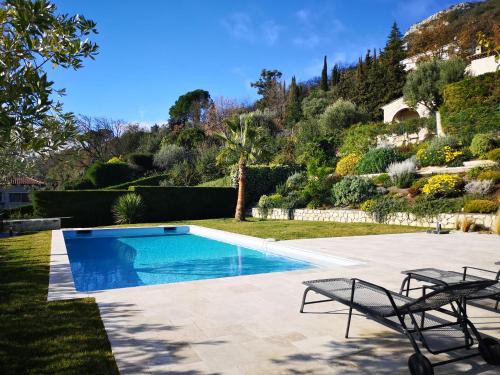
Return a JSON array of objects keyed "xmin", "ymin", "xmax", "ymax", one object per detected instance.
[{"xmin": 0, "ymin": 0, "xmax": 98, "ymax": 176}]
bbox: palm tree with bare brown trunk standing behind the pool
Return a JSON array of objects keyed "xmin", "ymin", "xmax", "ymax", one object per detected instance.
[{"xmin": 217, "ymin": 111, "xmax": 269, "ymax": 221}]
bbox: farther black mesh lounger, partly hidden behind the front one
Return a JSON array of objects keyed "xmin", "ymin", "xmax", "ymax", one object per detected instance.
[{"xmin": 400, "ymin": 266, "xmax": 500, "ymax": 310}]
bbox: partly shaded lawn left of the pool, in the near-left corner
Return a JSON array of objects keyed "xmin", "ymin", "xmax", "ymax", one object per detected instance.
[{"xmin": 0, "ymin": 232, "xmax": 118, "ymax": 375}]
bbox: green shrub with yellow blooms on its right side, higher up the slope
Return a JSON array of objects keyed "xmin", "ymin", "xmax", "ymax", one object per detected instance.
[{"xmin": 417, "ymin": 137, "xmax": 468, "ymax": 167}]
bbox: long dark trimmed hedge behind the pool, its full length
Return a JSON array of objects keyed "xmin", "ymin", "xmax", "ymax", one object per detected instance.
[{"xmin": 33, "ymin": 186, "xmax": 237, "ymax": 227}]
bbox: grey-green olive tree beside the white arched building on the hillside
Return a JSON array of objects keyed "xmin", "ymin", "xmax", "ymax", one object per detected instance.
[{"xmin": 403, "ymin": 58, "xmax": 467, "ymax": 113}]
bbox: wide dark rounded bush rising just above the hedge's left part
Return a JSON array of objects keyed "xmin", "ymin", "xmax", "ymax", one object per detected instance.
[{"xmin": 85, "ymin": 161, "xmax": 134, "ymax": 188}]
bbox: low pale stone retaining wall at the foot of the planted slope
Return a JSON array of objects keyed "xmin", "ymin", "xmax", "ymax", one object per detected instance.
[{"xmin": 252, "ymin": 208, "xmax": 496, "ymax": 229}]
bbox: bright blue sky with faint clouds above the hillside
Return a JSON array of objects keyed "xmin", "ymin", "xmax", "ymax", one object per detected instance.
[{"xmin": 49, "ymin": 0, "xmax": 458, "ymax": 125}]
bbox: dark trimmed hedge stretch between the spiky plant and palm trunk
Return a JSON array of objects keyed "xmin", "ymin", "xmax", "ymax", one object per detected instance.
[{"xmin": 130, "ymin": 186, "xmax": 237, "ymax": 222}]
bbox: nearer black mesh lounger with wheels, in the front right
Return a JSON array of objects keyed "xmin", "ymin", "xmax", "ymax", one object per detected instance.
[{"xmin": 300, "ymin": 278, "xmax": 500, "ymax": 375}]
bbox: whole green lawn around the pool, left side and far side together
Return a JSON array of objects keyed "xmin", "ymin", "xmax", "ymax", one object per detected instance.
[{"xmin": 0, "ymin": 219, "xmax": 422, "ymax": 375}]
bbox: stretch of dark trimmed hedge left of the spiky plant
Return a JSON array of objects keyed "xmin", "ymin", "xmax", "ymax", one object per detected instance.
[{"xmin": 32, "ymin": 190, "xmax": 128, "ymax": 227}]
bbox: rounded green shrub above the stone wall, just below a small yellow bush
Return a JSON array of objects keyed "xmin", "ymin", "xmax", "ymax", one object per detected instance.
[{"xmin": 331, "ymin": 176, "xmax": 377, "ymax": 206}]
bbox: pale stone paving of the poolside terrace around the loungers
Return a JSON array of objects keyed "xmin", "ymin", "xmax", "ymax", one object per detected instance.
[{"xmin": 91, "ymin": 233, "xmax": 500, "ymax": 375}]
